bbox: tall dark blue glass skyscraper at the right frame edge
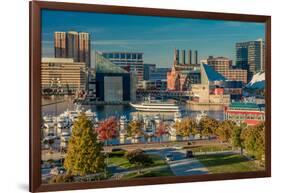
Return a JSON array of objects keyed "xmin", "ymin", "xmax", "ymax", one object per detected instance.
[{"xmin": 236, "ymin": 39, "xmax": 265, "ymax": 80}]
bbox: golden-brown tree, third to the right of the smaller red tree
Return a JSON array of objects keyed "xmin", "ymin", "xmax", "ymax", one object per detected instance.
[{"xmin": 215, "ymin": 120, "xmax": 236, "ymax": 142}]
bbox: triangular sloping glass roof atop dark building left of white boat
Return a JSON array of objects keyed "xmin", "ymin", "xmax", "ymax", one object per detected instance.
[{"xmin": 95, "ymin": 52, "xmax": 128, "ymax": 73}]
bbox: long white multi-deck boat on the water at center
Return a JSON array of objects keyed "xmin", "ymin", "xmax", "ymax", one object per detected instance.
[{"xmin": 130, "ymin": 100, "xmax": 181, "ymax": 112}]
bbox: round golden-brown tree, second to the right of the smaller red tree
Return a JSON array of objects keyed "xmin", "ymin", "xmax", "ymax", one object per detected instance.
[{"xmin": 198, "ymin": 117, "xmax": 219, "ymax": 138}]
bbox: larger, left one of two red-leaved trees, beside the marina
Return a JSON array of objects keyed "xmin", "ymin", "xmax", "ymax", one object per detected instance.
[{"xmin": 96, "ymin": 117, "xmax": 118, "ymax": 144}]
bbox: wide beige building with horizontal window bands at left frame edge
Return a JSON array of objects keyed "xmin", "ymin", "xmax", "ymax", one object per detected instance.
[{"xmin": 41, "ymin": 58, "xmax": 86, "ymax": 94}]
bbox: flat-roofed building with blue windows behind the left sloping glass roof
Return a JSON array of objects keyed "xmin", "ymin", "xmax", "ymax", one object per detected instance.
[{"xmin": 100, "ymin": 52, "xmax": 144, "ymax": 81}]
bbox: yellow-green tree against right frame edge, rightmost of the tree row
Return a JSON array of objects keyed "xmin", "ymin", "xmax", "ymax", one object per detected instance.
[{"xmin": 242, "ymin": 123, "xmax": 265, "ymax": 160}]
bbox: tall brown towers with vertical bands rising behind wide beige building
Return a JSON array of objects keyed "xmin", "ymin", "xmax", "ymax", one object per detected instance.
[{"xmin": 54, "ymin": 31, "xmax": 91, "ymax": 68}]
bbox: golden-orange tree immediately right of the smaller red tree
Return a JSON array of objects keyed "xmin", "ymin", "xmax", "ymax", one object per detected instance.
[{"xmin": 174, "ymin": 118, "xmax": 197, "ymax": 137}]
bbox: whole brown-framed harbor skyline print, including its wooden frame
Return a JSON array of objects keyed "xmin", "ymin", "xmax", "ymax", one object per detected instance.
[{"xmin": 30, "ymin": 1, "xmax": 271, "ymax": 192}]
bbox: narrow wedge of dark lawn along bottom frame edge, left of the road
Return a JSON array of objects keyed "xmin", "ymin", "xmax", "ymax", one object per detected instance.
[{"xmin": 122, "ymin": 165, "xmax": 174, "ymax": 179}]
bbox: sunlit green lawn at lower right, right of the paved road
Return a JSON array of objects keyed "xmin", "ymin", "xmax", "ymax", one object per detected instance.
[{"xmin": 196, "ymin": 154, "xmax": 263, "ymax": 173}]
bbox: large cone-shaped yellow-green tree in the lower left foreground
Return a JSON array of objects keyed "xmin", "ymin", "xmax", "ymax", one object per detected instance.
[{"xmin": 64, "ymin": 113, "xmax": 105, "ymax": 176}]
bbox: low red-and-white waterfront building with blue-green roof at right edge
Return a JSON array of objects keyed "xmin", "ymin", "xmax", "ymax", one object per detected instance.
[{"xmin": 224, "ymin": 102, "xmax": 265, "ymax": 125}]
